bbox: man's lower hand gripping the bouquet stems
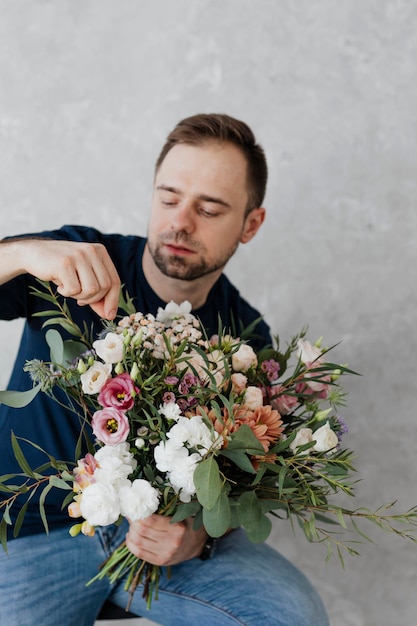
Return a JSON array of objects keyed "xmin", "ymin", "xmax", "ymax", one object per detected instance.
[{"xmin": 126, "ymin": 514, "xmax": 208, "ymax": 566}]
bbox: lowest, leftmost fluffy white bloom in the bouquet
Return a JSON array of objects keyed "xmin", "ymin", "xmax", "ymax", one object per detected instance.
[{"xmin": 80, "ymin": 483, "xmax": 120, "ymax": 526}]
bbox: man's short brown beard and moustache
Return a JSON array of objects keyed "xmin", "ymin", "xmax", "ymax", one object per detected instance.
[{"xmin": 148, "ymin": 233, "xmax": 239, "ymax": 281}]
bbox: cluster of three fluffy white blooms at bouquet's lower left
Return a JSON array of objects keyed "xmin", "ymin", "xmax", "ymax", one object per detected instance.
[{"xmin": 79, "ymin": 443, "xmax": 160, "ymax": 527}]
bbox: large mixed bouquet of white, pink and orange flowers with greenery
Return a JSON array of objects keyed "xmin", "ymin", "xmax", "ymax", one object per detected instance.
[{"xmin": 0, "ymin": 286, "xmax": 417, "ymax": 606}]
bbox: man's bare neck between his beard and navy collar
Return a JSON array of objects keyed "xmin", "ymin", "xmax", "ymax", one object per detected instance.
[{"xmin": 142, "ymin": 244, "xmax": 221, "ymax": 309}]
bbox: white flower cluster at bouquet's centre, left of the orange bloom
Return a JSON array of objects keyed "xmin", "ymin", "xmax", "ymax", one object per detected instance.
[{"xmin": 154, "ymin": 403, "xmax": 223, "ymax": 502}]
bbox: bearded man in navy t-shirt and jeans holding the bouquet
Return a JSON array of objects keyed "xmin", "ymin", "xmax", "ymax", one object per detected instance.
[{"xmin": 0, "ymin": 115, "xmax": 328, "ymax": 626}]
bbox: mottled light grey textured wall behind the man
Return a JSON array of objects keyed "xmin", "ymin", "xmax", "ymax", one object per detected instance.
[{"xmin": 0, "ymin": 0, "xmax": 417, "ymax": 626}]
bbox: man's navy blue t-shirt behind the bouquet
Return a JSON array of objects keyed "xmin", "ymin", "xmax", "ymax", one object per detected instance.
[{"xmin": 0, "ymin": 226, "xmax": 271, "ymax": 536}]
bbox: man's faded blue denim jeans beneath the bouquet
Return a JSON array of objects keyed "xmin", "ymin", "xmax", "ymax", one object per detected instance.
[{"xmin": 0, "ymin": 524, "xmax": 328, "ymax": 626}]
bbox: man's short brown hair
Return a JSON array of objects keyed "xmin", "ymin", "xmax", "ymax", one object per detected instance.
[{"xmin": 155, "ymin": 113, "xmax": 268, "ymax": 213}]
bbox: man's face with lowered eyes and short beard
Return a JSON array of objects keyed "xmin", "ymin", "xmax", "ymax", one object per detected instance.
[{"xmin": 148, "ymin": 143, "xmax": 248, "ymax": 281}]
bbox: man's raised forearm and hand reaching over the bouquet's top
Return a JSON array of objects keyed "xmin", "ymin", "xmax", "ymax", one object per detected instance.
[{"xmin": 0, "ymin": 238, "xmax": 120, "ymax": 319}]
